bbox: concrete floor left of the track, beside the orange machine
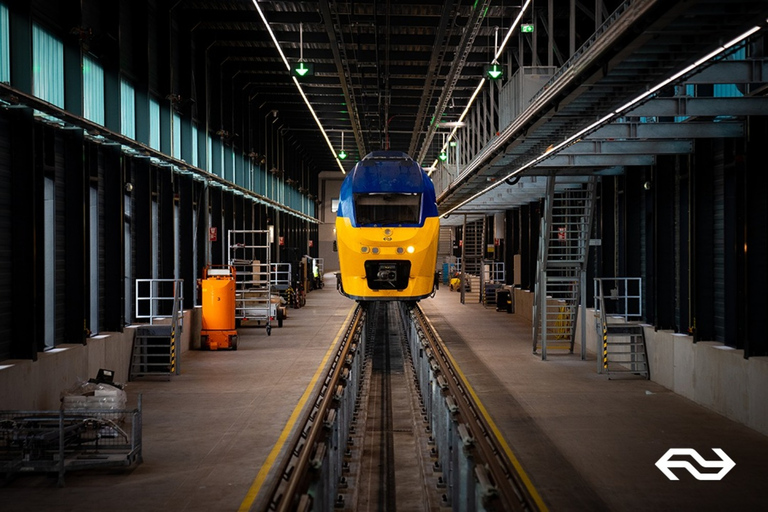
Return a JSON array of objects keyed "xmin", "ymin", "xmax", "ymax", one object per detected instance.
[{"xmin": 0, "ymin": 282, "xmax": 356, "ymax": 512}]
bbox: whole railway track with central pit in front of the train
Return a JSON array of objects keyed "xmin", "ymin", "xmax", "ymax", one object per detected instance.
[{"xmin": 266, "ymin": 302, "xmax": 539, "ymax": 511}]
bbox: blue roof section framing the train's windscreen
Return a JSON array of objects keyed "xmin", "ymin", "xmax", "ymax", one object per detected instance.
[{"xmin": 337, "ymin": 151, "xmax": 437, "ymax": 222}]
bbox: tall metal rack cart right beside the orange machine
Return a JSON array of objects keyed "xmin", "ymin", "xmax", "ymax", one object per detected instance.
[{"xmin": 227, "ymin": 230, "xmax": 277, "ymax": 336}]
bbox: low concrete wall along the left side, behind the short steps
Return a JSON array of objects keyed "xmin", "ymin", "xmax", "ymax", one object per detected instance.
[{"xmin": 0, "ymin": 308, "xmax": 201, "ymax": 410}]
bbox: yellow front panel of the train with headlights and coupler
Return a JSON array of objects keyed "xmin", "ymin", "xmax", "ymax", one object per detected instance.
[{"xmin": 336, "ymin": 217, "xmax": 440, "ymax": 300}]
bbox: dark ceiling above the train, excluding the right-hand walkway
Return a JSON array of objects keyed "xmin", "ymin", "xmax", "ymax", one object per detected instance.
[{"xmin": 176, "ymin": 0, "xmax": 621, "ymax": 172}]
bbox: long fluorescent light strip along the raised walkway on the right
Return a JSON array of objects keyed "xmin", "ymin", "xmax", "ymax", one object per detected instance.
[{"xmin": 441, "ymin": 24, "xmax": 768, "ymax": 217}]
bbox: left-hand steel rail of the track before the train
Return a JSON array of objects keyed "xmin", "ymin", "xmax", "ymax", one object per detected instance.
[{"xmin": 268, "ymin": 304, "xmax": 364, "ymax": 511}]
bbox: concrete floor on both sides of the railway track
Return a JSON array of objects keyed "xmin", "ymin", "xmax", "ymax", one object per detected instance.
[{"xmin": 0, "ymin": 276, "xmax": 768, "ymax": 512}]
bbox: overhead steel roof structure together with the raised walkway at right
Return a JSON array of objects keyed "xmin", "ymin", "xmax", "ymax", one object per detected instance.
[{"xmin": 170, "ymin": 0, "xmax": 768, "ymax": 223}]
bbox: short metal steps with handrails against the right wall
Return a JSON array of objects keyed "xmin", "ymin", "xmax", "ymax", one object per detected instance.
[{"xmin": 595, "ymin": 277, "xmax": 651, "ymax": 379}]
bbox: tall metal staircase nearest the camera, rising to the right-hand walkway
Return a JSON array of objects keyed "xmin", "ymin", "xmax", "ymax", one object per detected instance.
[{"xmin": 533, "ymin": 176, "xmax": 597, "ymax": 359}]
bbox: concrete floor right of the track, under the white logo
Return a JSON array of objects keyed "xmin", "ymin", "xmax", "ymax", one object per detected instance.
[{"xmin": 421, "ymin": 287, "xmax": 768, "ymax": 511}]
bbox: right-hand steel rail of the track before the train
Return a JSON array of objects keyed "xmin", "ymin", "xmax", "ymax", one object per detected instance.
[{"xmin": 411, "ymin": 305, "xmax": 539, "ymax": 510}]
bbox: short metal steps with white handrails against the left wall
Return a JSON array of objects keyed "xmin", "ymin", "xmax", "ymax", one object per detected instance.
[{"xmin": 128, "ymin": 279, "xmax": 184, "ymax": 380}]
